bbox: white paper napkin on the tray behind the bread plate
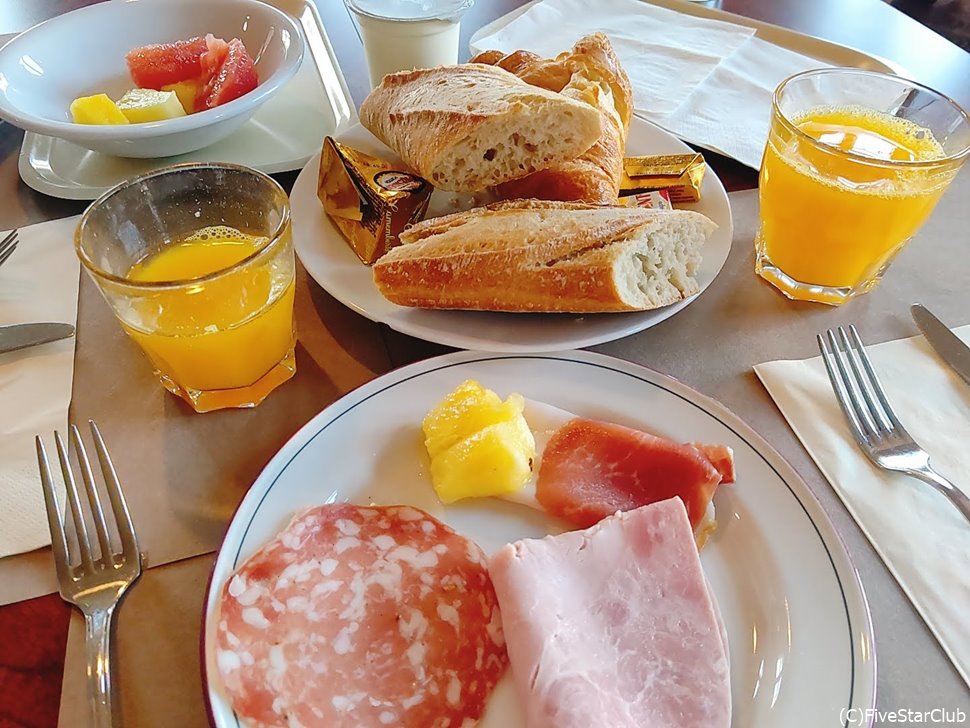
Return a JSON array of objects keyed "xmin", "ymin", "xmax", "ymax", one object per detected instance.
[{"xmin": 472, "ymin": 0, "xmax": 826, "ymax": 169}]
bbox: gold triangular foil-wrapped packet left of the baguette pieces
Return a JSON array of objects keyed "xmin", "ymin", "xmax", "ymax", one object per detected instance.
[{"xmin": 317, "ymin": 137, "xmax": 432, "ymax": 265}]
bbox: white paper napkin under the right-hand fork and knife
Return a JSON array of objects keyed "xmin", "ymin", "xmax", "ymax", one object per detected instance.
[{"xmin": 755, "ymin": 326, "xmax": 970, "ymax": 684}]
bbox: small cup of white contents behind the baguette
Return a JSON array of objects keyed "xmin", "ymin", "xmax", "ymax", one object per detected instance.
[{"xmin": 344, "ymin": 0, "xmax": 474, "ymax": 87}]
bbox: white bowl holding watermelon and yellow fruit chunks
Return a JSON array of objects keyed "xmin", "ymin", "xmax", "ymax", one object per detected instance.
[{"xmin": 0, "ymin": 0, "xmax": 304, "ymax": 161}]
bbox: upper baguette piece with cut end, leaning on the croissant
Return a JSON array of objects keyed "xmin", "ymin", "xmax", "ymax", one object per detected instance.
[{"xmin": 360, "ymin": 64, "xmax": 601, "ymax": 192}]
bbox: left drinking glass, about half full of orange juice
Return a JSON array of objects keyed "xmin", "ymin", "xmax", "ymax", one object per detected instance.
[{"xmin": 75, "ymin": 164, "xmax": 296, "ymax": 412}]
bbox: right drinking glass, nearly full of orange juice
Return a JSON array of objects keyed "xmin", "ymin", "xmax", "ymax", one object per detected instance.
[{"xmin": 755, "ymin": 68, "xmax": 970, "ymax": 305}]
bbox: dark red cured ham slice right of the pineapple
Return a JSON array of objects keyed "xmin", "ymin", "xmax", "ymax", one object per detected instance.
[{"xmin": 536, "ymin": 417, "xmax": 733, "ymax": 528}]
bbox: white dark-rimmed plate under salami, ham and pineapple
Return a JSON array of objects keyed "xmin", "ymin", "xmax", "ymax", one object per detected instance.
[{"xmin": 203, "ymin": 352, "xmax": 875, "ymax": 728}]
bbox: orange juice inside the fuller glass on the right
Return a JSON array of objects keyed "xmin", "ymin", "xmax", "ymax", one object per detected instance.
[{"xmin": 757, "ymin": 106, "xmax": 955, "ymax": 303}]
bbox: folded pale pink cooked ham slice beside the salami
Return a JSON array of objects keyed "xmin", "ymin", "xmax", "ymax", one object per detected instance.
[{"xmin": 489, "ymin": 498, "xmax": 731, "ymax": 728}]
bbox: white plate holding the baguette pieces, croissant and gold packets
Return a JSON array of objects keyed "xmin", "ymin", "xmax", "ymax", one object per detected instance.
[{"xmin": 290, "ymin": 118, "xmax": 733, "ymax": 353}]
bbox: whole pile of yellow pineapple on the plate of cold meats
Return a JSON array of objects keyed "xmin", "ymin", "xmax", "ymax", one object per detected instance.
[{"xmin": 422, "ymin": 380, "xmax": 536, "ymax": 503}]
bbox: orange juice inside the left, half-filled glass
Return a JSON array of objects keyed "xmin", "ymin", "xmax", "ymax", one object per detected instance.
[{"xmin": 122, "ymin": 226, "xmax": 294, "ymax": 406}]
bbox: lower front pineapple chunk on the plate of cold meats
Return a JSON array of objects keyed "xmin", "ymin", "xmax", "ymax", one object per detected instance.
[{"xmin": 431, "ymin": 417, "xmax": 535, "ymax": 503}]
